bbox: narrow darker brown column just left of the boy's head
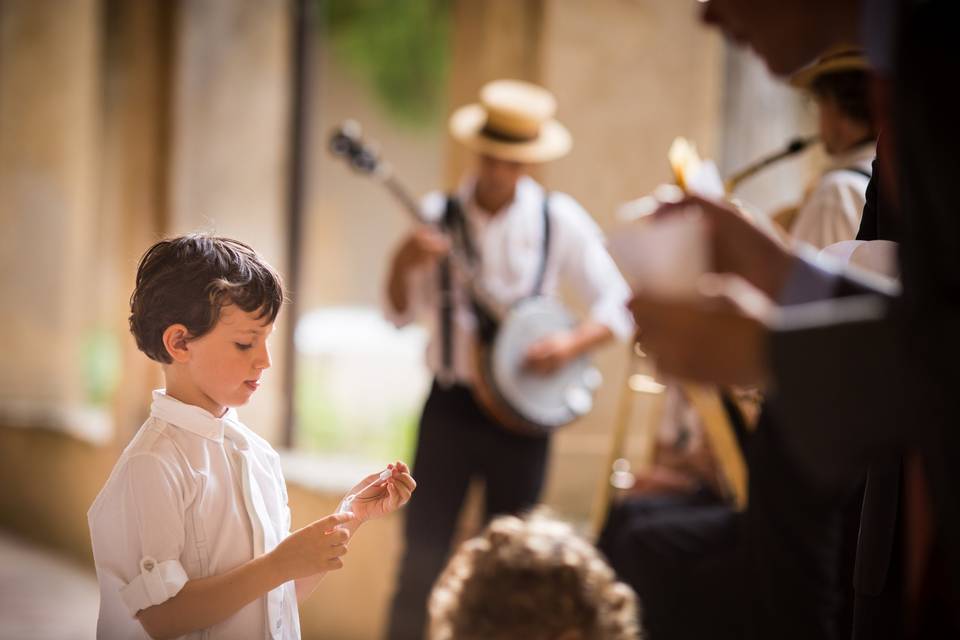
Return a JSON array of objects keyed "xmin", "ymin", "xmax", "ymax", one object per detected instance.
[{"xmin": 98, "ymin": 0, "xmax": 175, "ymax": 444}]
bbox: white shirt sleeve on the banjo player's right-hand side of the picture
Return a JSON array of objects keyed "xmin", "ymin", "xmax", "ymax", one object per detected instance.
[{"xmin": 551, "ymin": 194, "xmax": 634, "ymax": 341}]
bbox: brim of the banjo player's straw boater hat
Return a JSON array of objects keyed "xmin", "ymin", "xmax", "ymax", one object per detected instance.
[{"xmin": 449, "ymin": 104, "xmax": 573, "ymax": 164}]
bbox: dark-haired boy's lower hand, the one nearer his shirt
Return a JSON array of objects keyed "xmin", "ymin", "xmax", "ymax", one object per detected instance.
[{"xmin": 269, "ymin": 513, "xmax": 355, "ymax": 581}]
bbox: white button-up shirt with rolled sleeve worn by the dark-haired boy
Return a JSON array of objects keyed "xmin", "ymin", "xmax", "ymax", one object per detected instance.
[{"xmin": 87, "ymin": 390, "xmax": 300, "ymax": 640}]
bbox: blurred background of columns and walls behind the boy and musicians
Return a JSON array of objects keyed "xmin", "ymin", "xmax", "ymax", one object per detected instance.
[{"xmin": 0, "ymin": 0, "xmax": 822, "ymax": 640}]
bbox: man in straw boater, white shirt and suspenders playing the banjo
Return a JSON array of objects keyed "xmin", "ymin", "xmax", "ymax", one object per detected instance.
[{"xmin": 385, "ymin": 80, "xmax": 633, "ymax": 638}]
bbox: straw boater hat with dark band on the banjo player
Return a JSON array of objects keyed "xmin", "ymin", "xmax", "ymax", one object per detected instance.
[{"xmin": 450, "ymin": 80, "xmax": 573, "ymax": 164}]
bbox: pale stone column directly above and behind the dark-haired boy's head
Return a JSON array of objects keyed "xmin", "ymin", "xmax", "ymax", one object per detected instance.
[{"xmin": 169, "ymin": 0, "xmax": 290, "ymax": 442}]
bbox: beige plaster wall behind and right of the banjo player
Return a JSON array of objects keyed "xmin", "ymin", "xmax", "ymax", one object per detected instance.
[{"xmin": 541, "ymin": 0, "xmax": 723, "ymax": 518}]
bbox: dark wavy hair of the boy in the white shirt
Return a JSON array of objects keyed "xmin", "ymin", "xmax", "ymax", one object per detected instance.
[{"xmin": 130, "ymin": 234, "xmax": 284, "ymax": 364}]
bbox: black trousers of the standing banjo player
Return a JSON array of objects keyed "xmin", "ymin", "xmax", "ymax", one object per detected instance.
[{"xmin": 388, "ymin": 383, "xmax": 549, "ymax": 640}]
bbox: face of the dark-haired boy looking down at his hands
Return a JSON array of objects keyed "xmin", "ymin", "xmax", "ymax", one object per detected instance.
[{"xmin": 183, "ymin": 305, "xmax": 273, "ymax": 416}]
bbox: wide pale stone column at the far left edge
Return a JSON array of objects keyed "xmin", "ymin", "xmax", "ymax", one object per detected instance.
[{"xmin": 0, "ymin": 0, "xmax": 105, "ymax": 435}]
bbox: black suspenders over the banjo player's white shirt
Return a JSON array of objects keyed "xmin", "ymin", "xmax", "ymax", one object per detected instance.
[{"xmin": 437, "ymin": 192, "xmax": 551, "ymax": 386}]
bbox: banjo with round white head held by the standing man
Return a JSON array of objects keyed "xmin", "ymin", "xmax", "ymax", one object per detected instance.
[{"xmin": 330, "ymin": 121, "xmax": 602, "ymax": 436}]
